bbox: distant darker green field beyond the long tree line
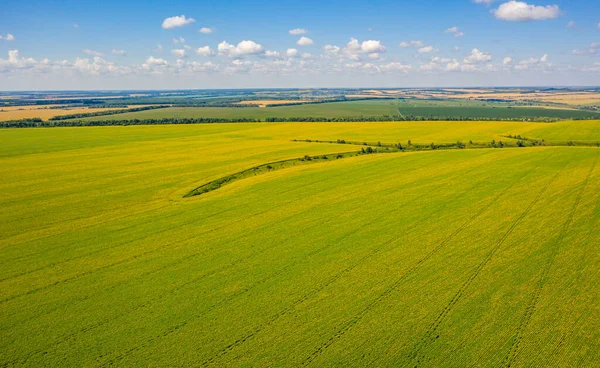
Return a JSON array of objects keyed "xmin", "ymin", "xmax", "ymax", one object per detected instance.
[{"xmin": 68, "ymin": 100, "xmax": 598, "ymax": 121}]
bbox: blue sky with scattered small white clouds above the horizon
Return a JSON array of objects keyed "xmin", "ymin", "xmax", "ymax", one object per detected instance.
[{"xmin": 0, "ymin": 0, "xmax": 600, "ymax": 90}]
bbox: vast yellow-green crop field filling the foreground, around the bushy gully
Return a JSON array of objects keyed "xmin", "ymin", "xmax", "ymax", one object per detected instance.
[{"xmin": 0, "ymin": 121, "xmax": 600, "ymax": 367}]
